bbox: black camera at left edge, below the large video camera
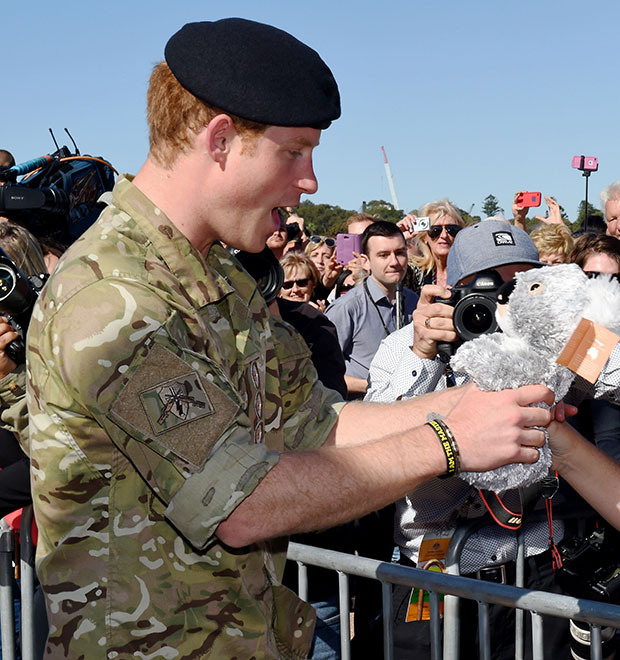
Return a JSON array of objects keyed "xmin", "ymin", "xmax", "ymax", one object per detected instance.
[{"xmin": 0, "ymin": 248, "xmax": 49, "ymax": 364}]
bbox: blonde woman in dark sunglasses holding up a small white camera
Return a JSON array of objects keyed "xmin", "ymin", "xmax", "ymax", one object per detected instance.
[{"xmin": 398, "ymin": 199, "xmax": 465, "ymax": 294}]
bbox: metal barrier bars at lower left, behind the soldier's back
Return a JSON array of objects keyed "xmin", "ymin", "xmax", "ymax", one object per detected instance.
[{"xmin": 0, "ymin": 506, "xmax": 35, "ymax": 660}]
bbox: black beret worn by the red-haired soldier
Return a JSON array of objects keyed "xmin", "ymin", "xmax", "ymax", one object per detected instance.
[{"xmin": 165, "ymin": 18, "xmax": 340, "ymax": 129}]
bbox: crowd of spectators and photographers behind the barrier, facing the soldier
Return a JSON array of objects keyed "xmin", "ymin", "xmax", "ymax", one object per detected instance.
[{"xmin": 256, "ymin": 184, "xmax": 620, "ymax": 658}]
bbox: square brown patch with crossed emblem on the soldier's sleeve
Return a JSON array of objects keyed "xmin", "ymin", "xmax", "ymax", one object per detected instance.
[{"xmin": 111, "ymin": 343, "xmax": 238, "ymax": 468}]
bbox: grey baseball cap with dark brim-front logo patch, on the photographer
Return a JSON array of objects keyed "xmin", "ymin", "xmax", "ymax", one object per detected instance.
[{"xmin": 447, "ymin": 220, "xmax": 544, "ymax": 286}]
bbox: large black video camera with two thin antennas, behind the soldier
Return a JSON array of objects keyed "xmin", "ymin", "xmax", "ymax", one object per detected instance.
[{"xmin": 0, "ymin": 129, "xmax": 116, "ymax": 245}]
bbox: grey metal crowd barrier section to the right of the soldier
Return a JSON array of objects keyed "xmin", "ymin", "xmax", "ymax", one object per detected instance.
[{"xmin": 288, "ymin": 543, "xmax": 620, "ymax": 660}]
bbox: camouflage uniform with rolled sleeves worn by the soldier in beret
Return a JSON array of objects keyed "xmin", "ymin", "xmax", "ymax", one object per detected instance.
[{"xmin": 28, "ymin": 178, "xmax": 342, "ymax": 660}]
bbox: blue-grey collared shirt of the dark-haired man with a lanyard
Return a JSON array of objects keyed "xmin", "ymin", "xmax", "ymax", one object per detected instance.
[{"xmin": 325, "ymin": 276, "xmax": 418, "ymax": 380}]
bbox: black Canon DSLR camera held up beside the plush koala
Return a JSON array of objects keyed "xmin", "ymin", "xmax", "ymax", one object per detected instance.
[{"xmin": 435, "ymin": 270, "xmax": 514, "ymax": 362}]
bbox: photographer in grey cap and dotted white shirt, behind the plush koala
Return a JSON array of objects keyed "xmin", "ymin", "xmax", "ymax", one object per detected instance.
[{"xmin": 366, "ymin": 220, "xmax": 568, "ymax": 659}]
